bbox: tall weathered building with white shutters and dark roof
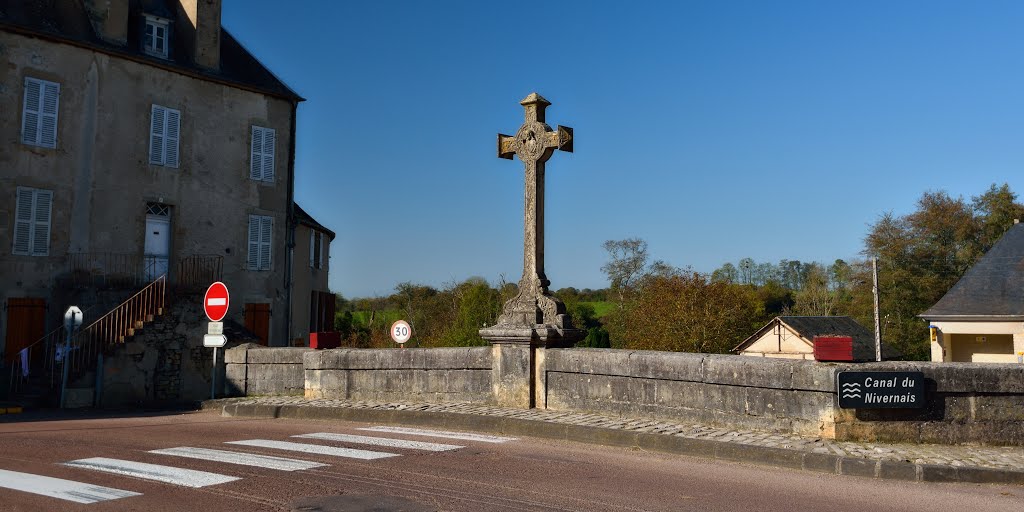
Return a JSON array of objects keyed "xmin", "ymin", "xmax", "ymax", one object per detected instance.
[{"xmin": 0, "ymin": 0, "xmax": 303, "ymax": 360}]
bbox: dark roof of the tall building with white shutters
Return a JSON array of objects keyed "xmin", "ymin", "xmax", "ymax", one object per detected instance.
[{"xmin": 0, "ymin": 0, "xmax": 303, "ymax": 101}]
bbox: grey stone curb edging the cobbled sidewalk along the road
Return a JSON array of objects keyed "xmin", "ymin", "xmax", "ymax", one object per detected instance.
[{"xmin": 216, "ymin": 399, "xmax": 1024, "ymax": 485}]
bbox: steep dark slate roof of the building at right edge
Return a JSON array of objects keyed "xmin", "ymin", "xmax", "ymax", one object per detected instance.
[{"xmin": 921, "ymin": 224, "xmax": 1024, "ymax": 322}]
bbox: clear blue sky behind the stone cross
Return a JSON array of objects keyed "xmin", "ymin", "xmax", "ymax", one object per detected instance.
[{"xmin": 223, "ymin": 0, "xmax": 1024, "ymax": 297}]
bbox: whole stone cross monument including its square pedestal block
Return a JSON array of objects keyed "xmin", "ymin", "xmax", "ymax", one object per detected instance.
[{"xmin": 480, "ymin": 92, "xmax": 586, "ymax": 408}]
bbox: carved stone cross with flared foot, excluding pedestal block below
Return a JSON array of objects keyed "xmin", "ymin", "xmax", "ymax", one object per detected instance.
[{"xmin": 480, "ymin": 92, "xmax": 582, "ymax": 343}]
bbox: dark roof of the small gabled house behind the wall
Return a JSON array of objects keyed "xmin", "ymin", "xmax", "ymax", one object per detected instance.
[{"xmin": 732, "ymin": 316, "xmax": 902, "ymax": 360}]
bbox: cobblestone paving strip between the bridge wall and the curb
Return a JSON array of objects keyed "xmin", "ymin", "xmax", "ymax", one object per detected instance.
[{"xmin": 218, "ymin": 396, "xmax": 1024, "ymax": 471}]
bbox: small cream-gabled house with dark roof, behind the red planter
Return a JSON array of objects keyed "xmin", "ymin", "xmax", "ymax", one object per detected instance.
[{"xmin": 732, "ymin": 316, "xmax": 898, "ymax": 361}]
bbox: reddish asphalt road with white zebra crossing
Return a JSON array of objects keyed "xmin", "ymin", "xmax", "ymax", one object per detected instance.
[{"xmin": 0, "ymin": 412, "xmax": 1024, "ymax": 512}]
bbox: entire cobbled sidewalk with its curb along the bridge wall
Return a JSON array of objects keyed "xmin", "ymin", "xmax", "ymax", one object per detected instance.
[{"xmin": 203, "ymin": 396, "xmax": 1024, "ymax": 484}]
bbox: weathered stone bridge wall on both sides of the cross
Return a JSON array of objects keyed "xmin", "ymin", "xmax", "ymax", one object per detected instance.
[{"xmin": 226, "ymin": 345, "xmax": 1024, "ymax": 445}]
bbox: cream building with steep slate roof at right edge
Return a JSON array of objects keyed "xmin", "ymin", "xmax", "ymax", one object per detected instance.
[{"xmin": 921, "ymin": 223, "xmax": 1024, "ymax": 362}]
